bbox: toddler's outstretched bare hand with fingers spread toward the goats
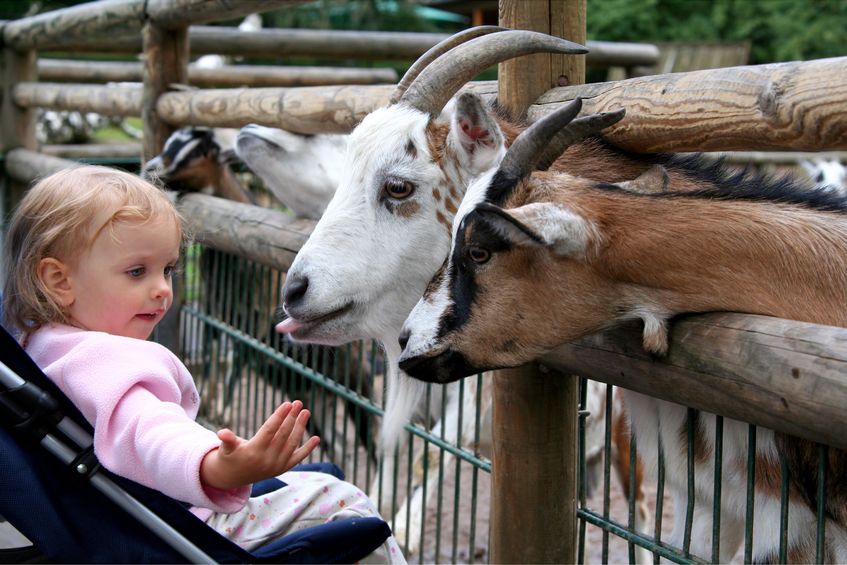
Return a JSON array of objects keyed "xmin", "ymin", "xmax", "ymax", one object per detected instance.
[{"xmin": 200, "ymin": 400, "xmax": 320, "ymax": 490}]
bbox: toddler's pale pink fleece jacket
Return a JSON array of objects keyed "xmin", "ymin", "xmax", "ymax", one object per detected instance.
[{"xmin": 26, "ymin": 325, "xmax": 250, "ymax": 519}]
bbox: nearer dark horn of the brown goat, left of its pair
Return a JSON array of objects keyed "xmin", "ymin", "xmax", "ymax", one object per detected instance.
[{"xmin": 499, "ymin": 98, "xmax": 582, "ymax": 179}]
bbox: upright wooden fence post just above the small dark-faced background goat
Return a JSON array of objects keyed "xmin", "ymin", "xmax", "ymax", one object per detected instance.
[{"xmin": 141, "ymin": 21, "xmax": 189, "ymax": 351}]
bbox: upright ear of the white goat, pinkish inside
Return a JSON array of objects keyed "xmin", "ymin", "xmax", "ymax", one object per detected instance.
[{"xmin": 450, "ymin": 92, "xmax": 506, "ymax": 175}]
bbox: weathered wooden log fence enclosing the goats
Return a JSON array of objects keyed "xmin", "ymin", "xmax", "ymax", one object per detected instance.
[{"xmin": 0, "ymin": 0, "xmax": 847, "ymax": 562}]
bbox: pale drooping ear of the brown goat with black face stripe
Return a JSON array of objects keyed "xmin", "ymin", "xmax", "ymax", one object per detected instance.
[{"xmin": 476, "ymin": 202, "xmax": 596, "ymax": 258}]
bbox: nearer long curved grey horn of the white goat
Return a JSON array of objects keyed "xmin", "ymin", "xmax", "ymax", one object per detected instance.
[{"xmin": 400, "ymin": 30, "xmax": 588, "ymax": 116}]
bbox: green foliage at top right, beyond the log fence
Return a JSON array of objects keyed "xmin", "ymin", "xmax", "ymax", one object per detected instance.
[{"xmin": 587, "ymin": 0, "xmax": 847, "ymax": 64}]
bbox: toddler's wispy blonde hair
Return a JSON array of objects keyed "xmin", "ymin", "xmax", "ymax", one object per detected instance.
[{"xmin": 3, "ymin": 165, "xmax": 185, "ymax": 339}]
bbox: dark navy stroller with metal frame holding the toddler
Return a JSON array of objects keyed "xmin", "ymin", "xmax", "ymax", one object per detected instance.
[{"xmin": 0, "ymin": 327, "xmax": 391, "ymax": 563}]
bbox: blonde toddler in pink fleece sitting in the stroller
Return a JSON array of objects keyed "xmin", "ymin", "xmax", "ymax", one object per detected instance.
[{"xmin": 4, "ymin": 166, "xmax": 405, "ymax": 563}]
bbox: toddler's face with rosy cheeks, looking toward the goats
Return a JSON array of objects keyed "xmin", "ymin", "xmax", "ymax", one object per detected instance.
[{"xmin": 69, "ymin": 218, "xmax": 180, "ymax": 339}]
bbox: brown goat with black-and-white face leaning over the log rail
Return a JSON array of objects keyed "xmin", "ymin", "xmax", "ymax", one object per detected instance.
[{"xmin": 400, "ymin": 99, "xmax": 847, "ymax": 563}]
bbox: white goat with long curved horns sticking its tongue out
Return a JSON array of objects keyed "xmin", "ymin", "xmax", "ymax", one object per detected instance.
[{"xmin": 277, "ymin": 28, "xmax": 664, "ymax": 552}]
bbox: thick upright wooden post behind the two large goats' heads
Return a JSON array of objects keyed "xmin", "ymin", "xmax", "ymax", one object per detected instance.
[{"xmin": 491, "ymin": 0, "xmax": 585, "ymax": 563}]
